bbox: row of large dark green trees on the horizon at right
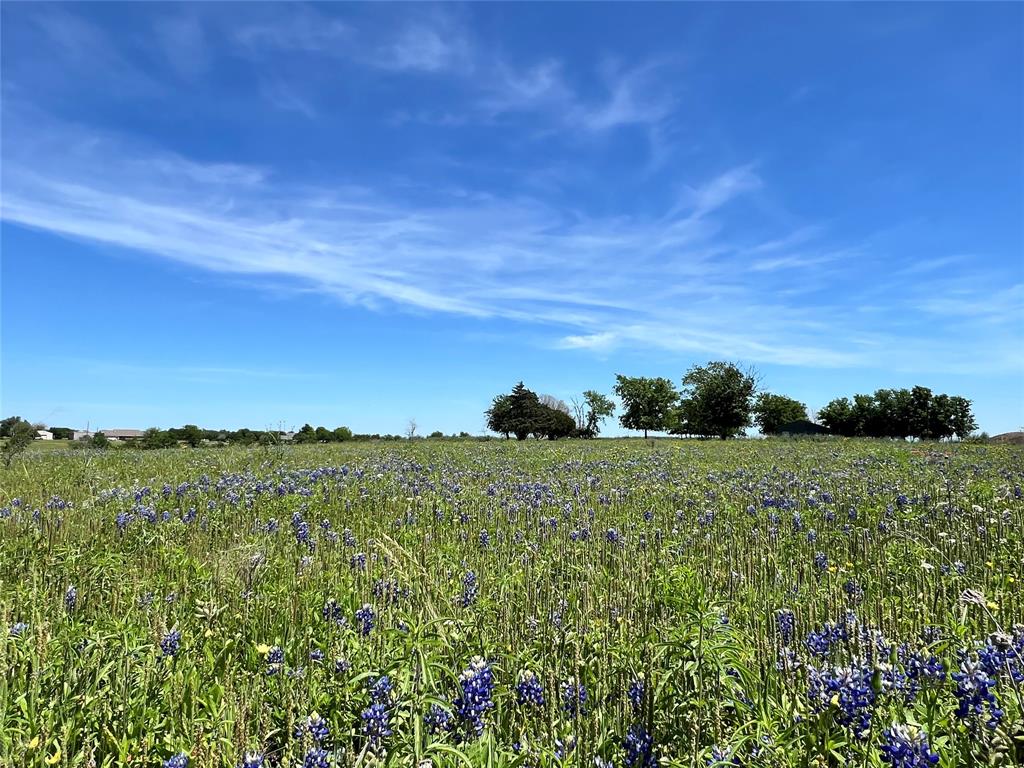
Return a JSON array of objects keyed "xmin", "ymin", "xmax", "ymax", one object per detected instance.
[{"xmin": 485, "ymin": 360, "xmax": 978, "ymax": 440}]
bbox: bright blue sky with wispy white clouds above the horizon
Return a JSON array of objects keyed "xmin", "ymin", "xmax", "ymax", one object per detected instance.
[{"xmin": 0, "ymin": 3, "xmax": 1024, "ymax": 433}]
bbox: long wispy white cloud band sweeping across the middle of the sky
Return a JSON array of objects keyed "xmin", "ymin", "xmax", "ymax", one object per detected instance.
[{"xmin": 2, "ymin": 116, "xmax": 1020, "ymax": 376}]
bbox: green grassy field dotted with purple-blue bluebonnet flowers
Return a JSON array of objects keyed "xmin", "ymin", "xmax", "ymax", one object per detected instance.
[{"xmin": 0, "ymin": 440, "xmax": 1024, "ymax": 768}]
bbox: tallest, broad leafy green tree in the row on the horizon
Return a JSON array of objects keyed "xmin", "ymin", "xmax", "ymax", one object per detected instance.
[{"xmin": 675, "ymin": 360, "xmax": 758, "ymax": 440}]
